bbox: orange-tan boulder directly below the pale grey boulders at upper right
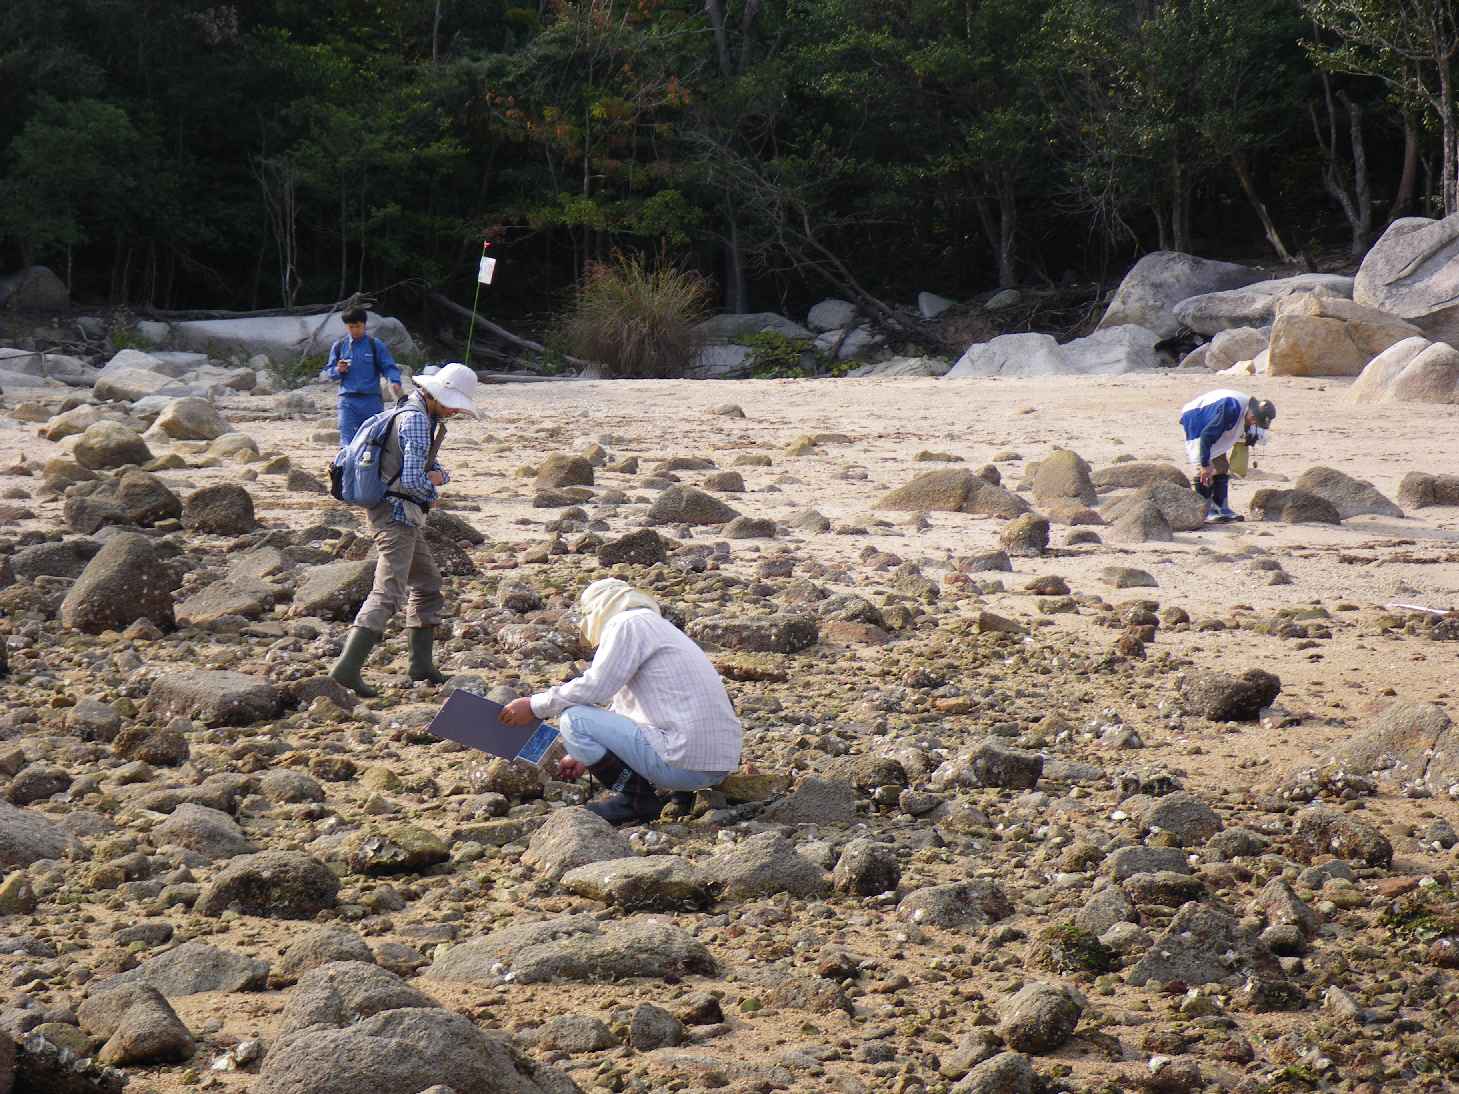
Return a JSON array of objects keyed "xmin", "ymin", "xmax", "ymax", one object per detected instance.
[{"xmin": 1268, "ymin": 293, "xmax": 1421, "ymax": 376}]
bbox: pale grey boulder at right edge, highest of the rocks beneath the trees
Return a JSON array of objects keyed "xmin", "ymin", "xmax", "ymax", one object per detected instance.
[{"xmin": 1352, "ymin": 214, "xmax": 1459, "ymax": 341}]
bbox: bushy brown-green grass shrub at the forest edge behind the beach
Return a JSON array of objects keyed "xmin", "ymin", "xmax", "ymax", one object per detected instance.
[{"xmin": 559, "ymin": 255, "xmax": 709, "ymax": 378}]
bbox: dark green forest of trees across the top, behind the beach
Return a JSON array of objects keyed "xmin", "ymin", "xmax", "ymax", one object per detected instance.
[{"xmin": 0, "ymin": 0, "xmax": 1459, "ymax": 325}]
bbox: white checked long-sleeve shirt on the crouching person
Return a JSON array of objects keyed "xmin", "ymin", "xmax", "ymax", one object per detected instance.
[{"xmin": 531, "ymin": 610, "xmax": 744, "ymax": 772}]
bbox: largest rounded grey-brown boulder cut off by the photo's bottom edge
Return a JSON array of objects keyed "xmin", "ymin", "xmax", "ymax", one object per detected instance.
[{"xmin": 254, "ymin": 1006, "xmax": 581, "ymax": 1094}]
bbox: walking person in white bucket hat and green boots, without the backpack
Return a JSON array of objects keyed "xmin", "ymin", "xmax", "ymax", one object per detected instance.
[{"xmin": 330, "ymin": 363, "xmax": 477, "ymax": 699}]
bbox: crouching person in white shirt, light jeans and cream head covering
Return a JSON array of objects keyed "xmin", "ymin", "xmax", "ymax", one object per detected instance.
[{"xmin": 502, "ymin": 578, "xmax": 744, "ymax": 824}]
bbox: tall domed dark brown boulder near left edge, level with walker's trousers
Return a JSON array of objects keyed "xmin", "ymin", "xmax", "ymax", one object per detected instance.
[{"xmin": 61, "ymin": 532, "xmax": 178, "ymax": 635}]
